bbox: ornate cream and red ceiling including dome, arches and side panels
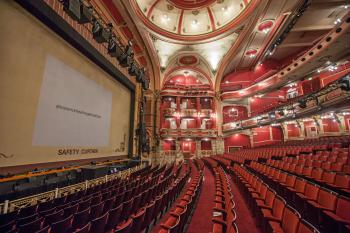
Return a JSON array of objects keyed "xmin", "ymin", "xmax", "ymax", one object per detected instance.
[{"xmin": 102, "ymin": 0, "xmax": 348, "ymax": 94}]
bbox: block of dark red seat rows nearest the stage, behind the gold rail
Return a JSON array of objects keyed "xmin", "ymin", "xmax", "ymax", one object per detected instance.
[{"xmin": 0, "ymin": 165, "xmax": 189, "ymax": 233}]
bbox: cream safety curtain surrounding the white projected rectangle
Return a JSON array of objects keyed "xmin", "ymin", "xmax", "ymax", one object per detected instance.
[{"xmin": 0, "ymin": 1, "xmax": 131, "ymax": 167}]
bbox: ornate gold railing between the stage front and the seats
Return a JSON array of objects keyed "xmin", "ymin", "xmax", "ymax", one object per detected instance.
[{"xmin": 0, "ymin": 164, "xmax": 146, "ymax": 214}]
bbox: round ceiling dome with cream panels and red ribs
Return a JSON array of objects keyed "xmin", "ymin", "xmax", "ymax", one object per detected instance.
[{"xmin": 133, "ymin": 0, "xmax": 257, "ymax": 40}]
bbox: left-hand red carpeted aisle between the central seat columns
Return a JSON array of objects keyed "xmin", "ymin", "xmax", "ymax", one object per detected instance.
[{"xmin": 187, "ymin": 167, "xmax": 215, "ymax": 233}]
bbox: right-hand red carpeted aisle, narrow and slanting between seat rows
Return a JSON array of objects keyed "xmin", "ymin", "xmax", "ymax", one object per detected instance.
[{"xmin": 227, "ymin": 176, "xmax": 261, "ymax": 233}]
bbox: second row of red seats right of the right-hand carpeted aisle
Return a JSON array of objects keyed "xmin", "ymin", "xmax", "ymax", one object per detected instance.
[{"xmin": 247, "ymin": 163, "xmax": 350, "ymax": 233}]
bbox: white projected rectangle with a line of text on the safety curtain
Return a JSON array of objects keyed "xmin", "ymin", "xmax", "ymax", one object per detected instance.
[{"xmin": 32, "ymin": 55, "xmax": 112, "ymax": 147}]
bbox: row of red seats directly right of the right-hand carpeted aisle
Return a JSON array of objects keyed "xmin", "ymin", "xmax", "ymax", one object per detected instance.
[{"xmin": 232, "ymin": 164, "xmax": 319, "ymax": 233}]
